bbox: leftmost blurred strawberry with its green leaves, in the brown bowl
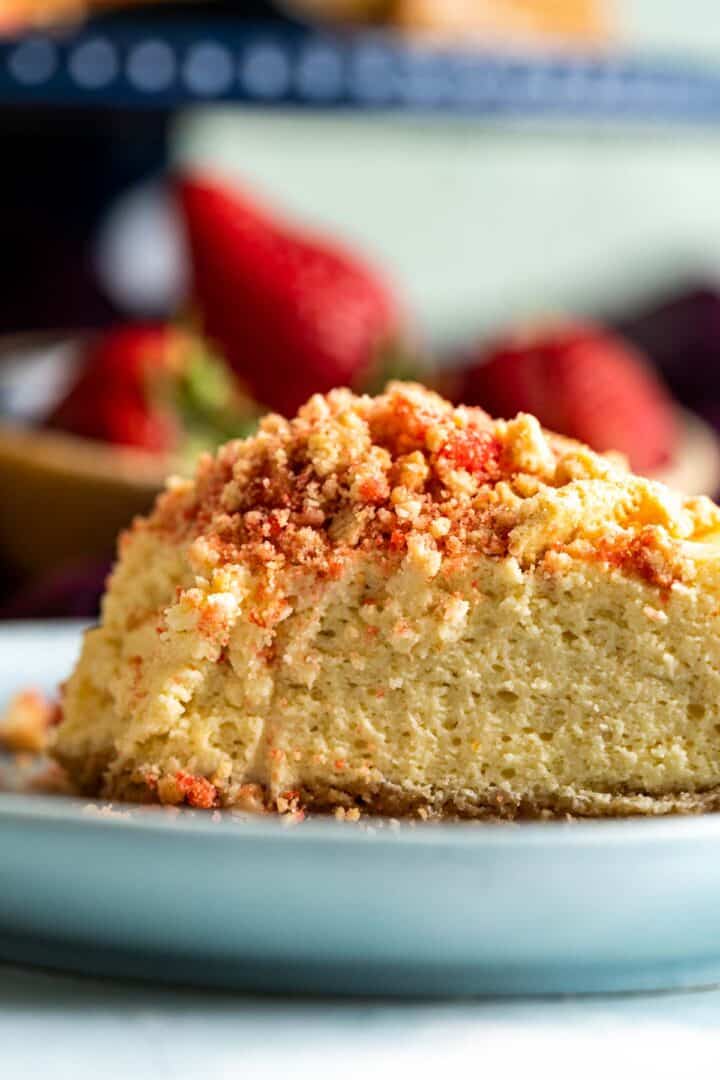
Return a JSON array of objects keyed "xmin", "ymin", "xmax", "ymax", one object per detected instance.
[{"xmin": 46, "ymin": 324, "xmax": 255, "ymax": 459}]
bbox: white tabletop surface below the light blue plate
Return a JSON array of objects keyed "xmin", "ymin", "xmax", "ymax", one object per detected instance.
[{"xmin": 0, "ymin": 966, "xmax": 720, "ymax": 1080}]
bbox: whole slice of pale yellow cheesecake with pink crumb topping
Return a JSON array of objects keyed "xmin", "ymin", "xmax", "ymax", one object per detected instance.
[{"xmin": 54, "ymin": 383, "xmax": 720, "ymax": 816}]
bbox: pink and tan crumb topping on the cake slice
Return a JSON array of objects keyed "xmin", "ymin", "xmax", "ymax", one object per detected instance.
[{"xmin": 143, "ymin": 382, "xmax": 720, "ymax": 609}]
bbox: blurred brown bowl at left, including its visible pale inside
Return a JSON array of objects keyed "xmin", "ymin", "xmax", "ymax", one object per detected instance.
[{"xmin": 0, "ymin": 334, "xmax": 175, "ymax": 575}]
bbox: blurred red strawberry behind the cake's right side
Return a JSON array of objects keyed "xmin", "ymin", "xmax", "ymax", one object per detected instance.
[{"xmin": 453, "ymin": 323, "xmax": 677, "ymax": 472}]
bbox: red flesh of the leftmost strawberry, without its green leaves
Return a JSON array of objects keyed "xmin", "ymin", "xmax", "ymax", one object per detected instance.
[{"xmin": 47, "ymin": 325, "xmax": 181, "ymax": 453}]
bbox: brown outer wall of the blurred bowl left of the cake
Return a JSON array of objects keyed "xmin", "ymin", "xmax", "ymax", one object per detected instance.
[{"xmin": 0, "ymin": 424, "xmax": 166, "ymax": 572}]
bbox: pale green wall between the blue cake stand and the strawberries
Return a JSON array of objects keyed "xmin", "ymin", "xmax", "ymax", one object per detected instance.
[{"xmin": 176, "ymin": 110, "xmax": 720, "ymax": 340}]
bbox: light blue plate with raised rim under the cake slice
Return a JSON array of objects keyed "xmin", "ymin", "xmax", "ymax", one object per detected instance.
[{"xmin": 0, "ymin": 623, "xmax": 720, "ymax": 996}]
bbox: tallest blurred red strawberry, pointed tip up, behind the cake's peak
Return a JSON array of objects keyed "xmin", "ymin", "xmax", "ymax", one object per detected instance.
[{"xmin": 178, "ymin": 177, "xmax": 400, "ymax": 416}]
